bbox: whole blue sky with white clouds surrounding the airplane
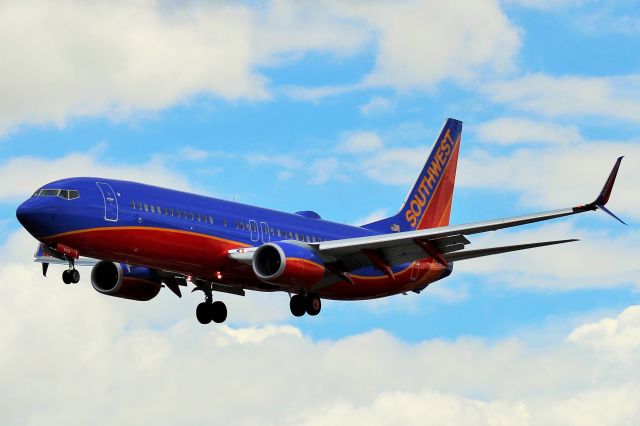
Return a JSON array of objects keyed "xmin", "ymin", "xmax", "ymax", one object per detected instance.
[{"xmin": 0, "ymin": 0, "xmax": 640, "ymax": 425}]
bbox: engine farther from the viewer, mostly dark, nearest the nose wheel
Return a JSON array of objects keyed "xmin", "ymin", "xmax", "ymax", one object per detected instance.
[{"xmin": 91, "ymin": 260, "xmax": 162, "ymax": 301}]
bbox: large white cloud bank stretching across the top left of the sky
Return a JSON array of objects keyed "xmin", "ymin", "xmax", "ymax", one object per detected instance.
[{"xmin": 0, "ymin": 0, "xmax": 519, "ymax": 135}]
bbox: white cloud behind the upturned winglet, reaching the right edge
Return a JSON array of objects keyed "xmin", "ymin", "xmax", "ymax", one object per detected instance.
[{"xmin": 456, "ymin": 141, "xmax": 640, "ymax": 220}]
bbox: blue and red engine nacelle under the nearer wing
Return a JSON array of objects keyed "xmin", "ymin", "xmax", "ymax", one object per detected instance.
[{"xmin": 252, "ymin": 242, "xmax": 325, "ymax": 288}]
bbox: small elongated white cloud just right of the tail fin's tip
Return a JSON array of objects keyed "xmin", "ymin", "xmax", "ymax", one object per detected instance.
[{"xmin": 475, "ymin": 117, "xmax": 582, "ymax": 145}]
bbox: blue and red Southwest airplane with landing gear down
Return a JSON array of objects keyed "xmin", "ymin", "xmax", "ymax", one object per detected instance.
[{"xmin": 16, "ymin": 118, "xmax": 624, "ymax": 324}]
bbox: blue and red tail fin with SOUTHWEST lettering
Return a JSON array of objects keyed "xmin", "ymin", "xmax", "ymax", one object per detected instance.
[{"xmin": 363, "ymin": 118, "xmax": 462, "ymax": 233}]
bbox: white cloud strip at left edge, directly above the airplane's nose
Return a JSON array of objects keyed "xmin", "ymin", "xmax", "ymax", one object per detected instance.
[{"xmin": 0, "ymin": 146, "xmax": 190, "ymax": 200}]
